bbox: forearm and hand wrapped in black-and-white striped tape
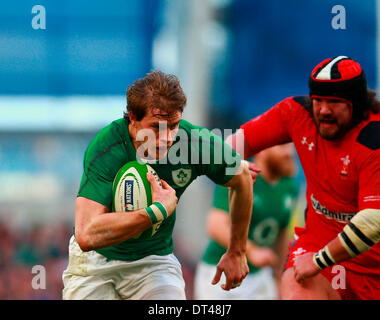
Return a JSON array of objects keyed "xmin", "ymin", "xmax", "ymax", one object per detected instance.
[{"xmin": 294, "ymin": 209, "xmax": 380, "ymax": 281}]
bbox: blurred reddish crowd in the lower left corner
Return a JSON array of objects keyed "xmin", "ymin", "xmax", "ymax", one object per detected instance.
[{"xmin": 0, "ymin": 220, "xmax": 73, "ymax": 300}]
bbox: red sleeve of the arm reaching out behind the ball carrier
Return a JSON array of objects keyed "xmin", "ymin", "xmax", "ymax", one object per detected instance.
[{"xmin": 240, "ymin": 98, "xmax": 296, "ymax": 154}]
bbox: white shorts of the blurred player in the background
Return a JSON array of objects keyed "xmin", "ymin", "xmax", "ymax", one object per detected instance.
[{"xmin": 194, "ymin": 261, "xmax": 278, "ymax": 300}]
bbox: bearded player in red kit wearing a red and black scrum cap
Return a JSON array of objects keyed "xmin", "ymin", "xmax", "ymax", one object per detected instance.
[{"xmin": 228, "ymin": 56, "xmax": 380, "ymax": 299}]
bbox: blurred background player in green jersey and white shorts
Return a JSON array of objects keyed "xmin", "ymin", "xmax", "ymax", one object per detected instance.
[{"xmin": 194, "ymin": 143, "xmax": 298, "ymax": 300}]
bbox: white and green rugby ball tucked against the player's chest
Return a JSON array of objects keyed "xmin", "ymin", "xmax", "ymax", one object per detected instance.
[{"xmin": 112, "ymin": 161, "xmax": 162, "ymax": 239}]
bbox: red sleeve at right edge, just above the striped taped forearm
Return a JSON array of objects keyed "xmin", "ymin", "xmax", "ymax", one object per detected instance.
[{"xmin": 358, "ymin": 149, "xmax": 380, "ymax": 211}]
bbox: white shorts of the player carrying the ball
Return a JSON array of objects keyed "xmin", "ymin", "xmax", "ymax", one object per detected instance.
[{"xmin": 62, "ymin": 236, "xmax": 186, "ymax": 300}]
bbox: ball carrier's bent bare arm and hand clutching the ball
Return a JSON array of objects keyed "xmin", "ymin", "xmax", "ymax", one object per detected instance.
[{"xmin": 75, "ymin": 174, "xmax": 178, "ymax": 251}]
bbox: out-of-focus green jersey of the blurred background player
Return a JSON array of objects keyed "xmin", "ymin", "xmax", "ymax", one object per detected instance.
[{"xmin": 202, "ymin": 175, "xmax": 298, "ymax": 273}]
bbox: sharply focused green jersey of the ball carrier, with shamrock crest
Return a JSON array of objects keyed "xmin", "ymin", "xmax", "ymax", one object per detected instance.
[{"xmin": 78, "ymin": 118, "xmax": 241, "ymax": 261}]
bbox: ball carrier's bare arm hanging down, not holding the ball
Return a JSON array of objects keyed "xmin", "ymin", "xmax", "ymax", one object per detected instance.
[{"xmin": 212, "ymin": 162, "xmax": 253, "ymax": 290}]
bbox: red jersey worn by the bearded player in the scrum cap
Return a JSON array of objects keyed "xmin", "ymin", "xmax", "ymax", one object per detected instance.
[{"xmin": 241, "ymin": 96, "xmax": 380, "ymax": 274}]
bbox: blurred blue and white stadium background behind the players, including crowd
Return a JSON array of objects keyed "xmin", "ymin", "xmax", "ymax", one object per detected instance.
[{"xmin": 0, "ymin": 0, "xmax": 378, "ymax": 299}]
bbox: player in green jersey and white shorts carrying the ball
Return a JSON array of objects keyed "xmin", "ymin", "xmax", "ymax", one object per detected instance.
[{"xmin": 63, "ymin": 71, "xmax": 253, "ymax": 300}]
